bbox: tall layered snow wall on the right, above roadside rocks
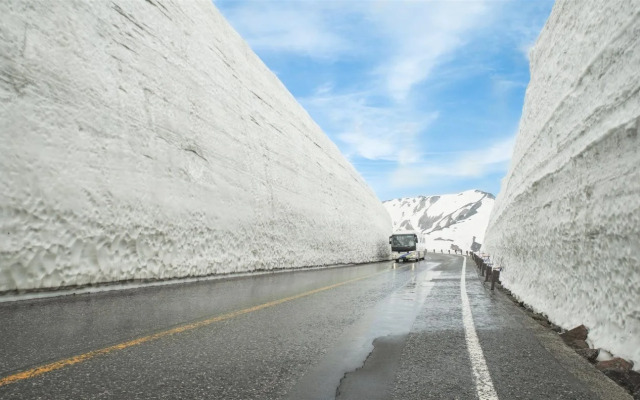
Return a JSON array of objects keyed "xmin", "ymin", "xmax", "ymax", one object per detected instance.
[{"xmin": 486, "ymin": 0, "xmax": 640, "ymax": 369}]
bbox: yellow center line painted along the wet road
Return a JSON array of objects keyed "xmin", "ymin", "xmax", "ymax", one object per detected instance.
[{"xmin": 0, "ymin": 270, "xmax": 400, "ymax": 386}]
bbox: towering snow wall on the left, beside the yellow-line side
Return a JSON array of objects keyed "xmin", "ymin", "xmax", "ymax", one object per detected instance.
[{"xmin": 0, "ymin": 0, "xmax": 391, "ymax": 292}]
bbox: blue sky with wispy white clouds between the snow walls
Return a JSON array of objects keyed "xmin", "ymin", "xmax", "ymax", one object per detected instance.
[{"xmin": 214, "ymin": 0, "xmax": 553, "ymax": 200}]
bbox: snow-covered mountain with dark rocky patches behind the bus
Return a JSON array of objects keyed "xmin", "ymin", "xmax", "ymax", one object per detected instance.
[{"xmin": 383, "ymin": 190, "xmax": 495, "ymax": 251}]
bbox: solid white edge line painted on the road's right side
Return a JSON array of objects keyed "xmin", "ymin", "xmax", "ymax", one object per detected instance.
[{"xmin": 460, "ymin": 257, "xmax": 498, "ymax": 400}]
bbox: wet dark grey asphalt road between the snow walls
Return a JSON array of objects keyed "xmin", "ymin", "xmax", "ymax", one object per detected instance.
[{"xmin": 0, "ymin": 254, "xmax": 630, "ymax": 399}]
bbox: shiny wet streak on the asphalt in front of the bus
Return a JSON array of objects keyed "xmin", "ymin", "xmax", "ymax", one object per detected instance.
[{"xmin": 288, "ymin": 262, "xmax": 441, "ymax": 399}]
